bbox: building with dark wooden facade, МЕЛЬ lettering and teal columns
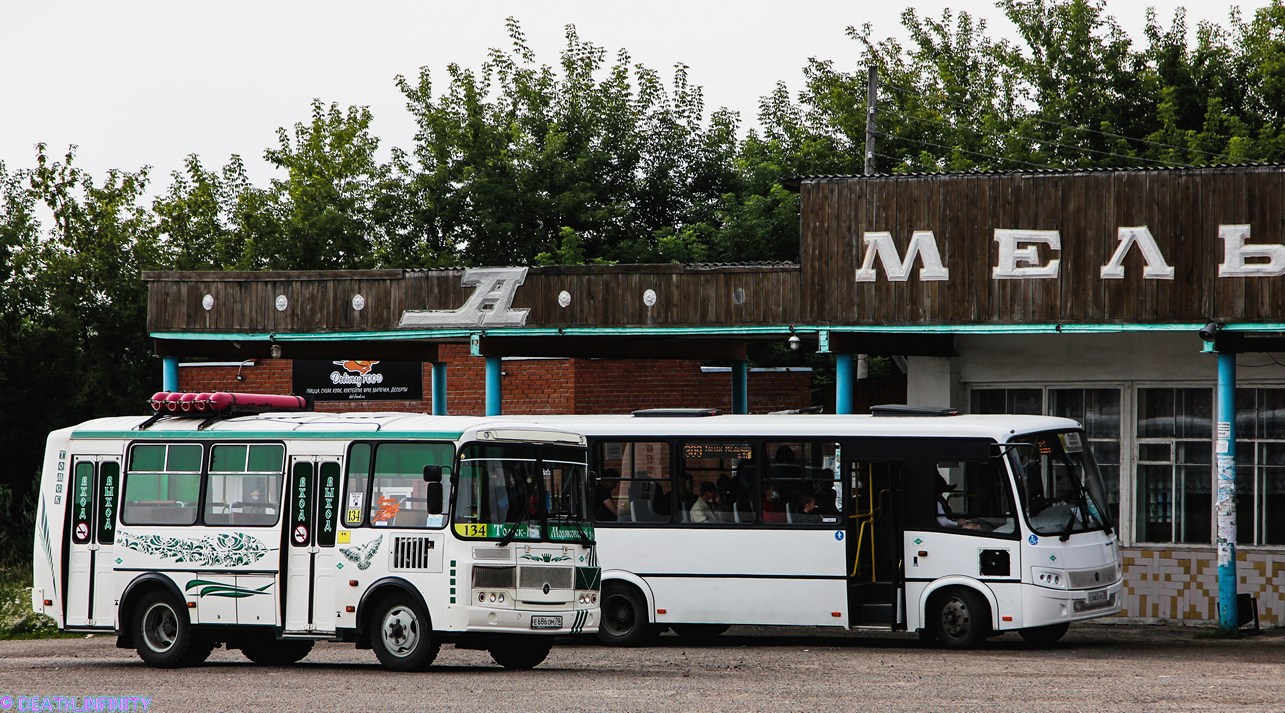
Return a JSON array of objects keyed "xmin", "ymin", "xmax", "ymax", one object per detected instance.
[{"xmin": 144, "ymin": 166, "xmax": 1285, "ymax": 624}]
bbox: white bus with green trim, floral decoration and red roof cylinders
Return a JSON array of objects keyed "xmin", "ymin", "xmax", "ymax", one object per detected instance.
[{"xmin": 32, "ymin": 394, "xmax": 600, "ymax": 671}]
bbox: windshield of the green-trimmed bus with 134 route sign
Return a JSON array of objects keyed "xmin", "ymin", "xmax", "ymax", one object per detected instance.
[{"xmin": 455, "ymin": 443, "xmax": 586, "ymax": 540}]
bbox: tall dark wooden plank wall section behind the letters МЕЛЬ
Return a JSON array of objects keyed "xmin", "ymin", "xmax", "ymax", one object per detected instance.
[{"xmin": 801, "ymin": 166, "xmax": 1285, "ymax": 325}]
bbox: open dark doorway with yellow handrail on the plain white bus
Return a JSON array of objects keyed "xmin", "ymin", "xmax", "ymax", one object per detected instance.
[{"xmin": 843, "ymin": 459, "xmax": 905, "ymax": 626}]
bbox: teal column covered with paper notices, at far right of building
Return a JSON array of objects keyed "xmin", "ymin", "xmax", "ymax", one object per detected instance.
[{"xmin": 1214, "ymin": 352, "xmax": 1240, "ymax": 631}]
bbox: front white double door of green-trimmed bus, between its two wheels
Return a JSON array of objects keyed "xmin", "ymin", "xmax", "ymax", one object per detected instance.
[{"xmin": 283, "ymin": 456, "xmax": 339, "ymax": 636}]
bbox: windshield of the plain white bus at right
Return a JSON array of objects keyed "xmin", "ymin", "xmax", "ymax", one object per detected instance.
[{"xmin": 1009, "ymin": 430, "xmax": 1112, "ymax": 536}]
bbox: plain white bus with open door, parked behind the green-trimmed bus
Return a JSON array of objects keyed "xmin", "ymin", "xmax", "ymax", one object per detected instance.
[{"xmin": 516, "ymin": 406, "xmax": 1122, "ymax": 647}]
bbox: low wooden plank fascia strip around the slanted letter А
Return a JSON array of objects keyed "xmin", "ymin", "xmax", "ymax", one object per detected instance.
[{"xmin": 144, "ymin": 265, "xmax": 801, "ymax": 333}]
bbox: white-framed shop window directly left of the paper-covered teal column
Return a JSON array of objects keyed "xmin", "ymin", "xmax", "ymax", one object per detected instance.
[{"xmin": 1135, "ymin": 388, "xmax": 1213, "ymax": 543}]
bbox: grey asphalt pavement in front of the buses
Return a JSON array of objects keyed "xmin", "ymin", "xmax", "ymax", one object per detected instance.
[{"xmin": 0, "ymin": 624, "xmax": 1285, "ymax": 713}]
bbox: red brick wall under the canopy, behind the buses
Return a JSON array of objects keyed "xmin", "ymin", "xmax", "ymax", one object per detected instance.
[{"xmin": 179, "ymin": 344, "xmax": 812, "ymax": 415}]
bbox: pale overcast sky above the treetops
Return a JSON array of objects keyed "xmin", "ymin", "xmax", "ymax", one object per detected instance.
[{"xmin": 0, "ymin": 0, "xmax": 1267, "ymax": 193}]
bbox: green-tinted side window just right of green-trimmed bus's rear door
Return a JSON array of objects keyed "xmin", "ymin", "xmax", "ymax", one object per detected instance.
[{"xmin": 121, "ymin": 443, "xmax": 203, "ymax": 525}]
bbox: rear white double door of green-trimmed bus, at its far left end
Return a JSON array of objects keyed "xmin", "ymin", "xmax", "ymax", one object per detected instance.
[{"xmin": 63, "ymin": 456, "xmax": 121, "ymax": 628}]
